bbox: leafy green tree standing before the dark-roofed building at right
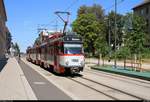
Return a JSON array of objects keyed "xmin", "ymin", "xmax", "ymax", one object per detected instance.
[{"xmin": 125, "ymin": 14, "xmax": 146, "ymax": 70}]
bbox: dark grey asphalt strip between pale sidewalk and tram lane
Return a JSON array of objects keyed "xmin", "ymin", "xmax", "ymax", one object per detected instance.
[{"xmin": 19, "ymin": 61, "xmax": 72, "ymax": 100}]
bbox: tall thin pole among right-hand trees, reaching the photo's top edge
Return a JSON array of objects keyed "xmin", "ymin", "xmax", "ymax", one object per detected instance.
[{"xmin": 114, "ymin": 0, "xmax": 117, "ymax": 68}]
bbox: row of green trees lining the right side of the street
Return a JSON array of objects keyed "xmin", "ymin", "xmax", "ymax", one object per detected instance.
[{"xmin": 72, "ymin": 4, "xmax": 150, "ymax": 67}]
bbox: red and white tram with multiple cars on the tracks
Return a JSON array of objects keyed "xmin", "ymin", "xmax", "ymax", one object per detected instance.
[{"xmin": 27, "ymin": 33, "xmax": 85, "ymax": 74}]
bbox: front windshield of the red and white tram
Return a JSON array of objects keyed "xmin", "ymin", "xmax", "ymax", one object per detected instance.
[{"xmin": 64, "ymin": 44, "xmax": 82, "ymax": 54}]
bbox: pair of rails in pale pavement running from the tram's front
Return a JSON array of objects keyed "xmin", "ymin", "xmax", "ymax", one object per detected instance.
[{"xmin": 68, "ymin": 77, "xmax": 143, "ymax": 100}]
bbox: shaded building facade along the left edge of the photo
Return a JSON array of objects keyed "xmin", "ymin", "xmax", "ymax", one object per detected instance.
[{"xmin": 0, "ymin": 0, "xmax": 7, "ymax": 58}]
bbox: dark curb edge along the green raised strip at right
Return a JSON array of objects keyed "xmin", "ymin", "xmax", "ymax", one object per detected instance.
[{"xmin": 91, "ymin": 67, "xmax": 150, "ymax": 81}]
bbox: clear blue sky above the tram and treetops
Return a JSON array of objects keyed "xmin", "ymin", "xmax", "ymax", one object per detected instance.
[{"xmin": 4, "ymin": 0, "xmax": 143, "ymax": 52}]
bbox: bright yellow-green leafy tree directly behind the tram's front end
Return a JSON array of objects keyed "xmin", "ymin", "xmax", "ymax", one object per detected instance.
[{"xmin": 72, "ymin": 14, "xmax": 101, "ymax": 55}]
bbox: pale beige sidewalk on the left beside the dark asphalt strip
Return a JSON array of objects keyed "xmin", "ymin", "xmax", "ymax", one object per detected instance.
[{"xmin": 0, "ymin": 58, "xmax": 37, "ymax": 100}]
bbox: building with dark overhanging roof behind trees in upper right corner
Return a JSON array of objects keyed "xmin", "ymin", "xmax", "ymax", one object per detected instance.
[{"xmin": 133, "ymin": 0, "xmax": 150, "ymax": 46}]
